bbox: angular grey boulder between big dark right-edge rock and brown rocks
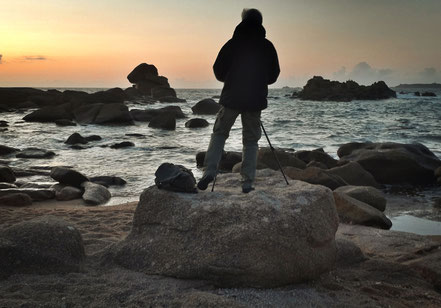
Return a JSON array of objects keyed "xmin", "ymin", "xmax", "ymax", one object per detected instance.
[{"xmin": 327, "ymin": 161, "xmax": 381, "ymax": 188}]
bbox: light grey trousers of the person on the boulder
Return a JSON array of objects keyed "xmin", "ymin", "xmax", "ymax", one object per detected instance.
[{"xmin": 204, "ymin": 106, "xmax": 262, "ymax": 187}]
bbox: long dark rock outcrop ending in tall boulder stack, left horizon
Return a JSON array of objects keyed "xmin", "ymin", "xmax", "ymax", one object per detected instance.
[{"xmin": 0, "ymin": 63, "xmax": 185, "ymax": 126}]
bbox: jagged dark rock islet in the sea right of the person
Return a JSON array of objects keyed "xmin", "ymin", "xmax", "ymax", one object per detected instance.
[{"xmin": 295, "ymin": 76, "xmax": 397, "ymax": 102}]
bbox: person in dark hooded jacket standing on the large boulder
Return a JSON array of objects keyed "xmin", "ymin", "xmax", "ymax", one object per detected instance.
[{"xmin": 197, "ymin": 9, "xmax": 280, "ymax": 193}]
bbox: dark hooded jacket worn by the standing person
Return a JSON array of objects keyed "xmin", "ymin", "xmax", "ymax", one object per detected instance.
[{"xmin": 213, "ymin": 20, "xmax": 280, "ymax": 111}]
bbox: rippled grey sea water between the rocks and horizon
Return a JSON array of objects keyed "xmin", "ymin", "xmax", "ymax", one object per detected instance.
[{"xmin": 0, "ymin": 88, "xmax": 441, "ymax": 205}]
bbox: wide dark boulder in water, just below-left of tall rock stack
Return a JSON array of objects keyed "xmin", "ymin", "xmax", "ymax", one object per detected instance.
[{"xmin": 74, "ymin": 103, "xmax": 133, "ymax": 124}]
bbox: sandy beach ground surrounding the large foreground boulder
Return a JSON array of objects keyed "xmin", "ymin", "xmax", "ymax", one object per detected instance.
[{"xmin": 0, "ymin": 195, "xmax": 441, "ymax": 307}]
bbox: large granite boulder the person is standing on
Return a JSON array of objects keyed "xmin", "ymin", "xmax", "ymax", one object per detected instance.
[{"xmin": 102, "ymin": 169, "xmax": 338, "ymax": 287}]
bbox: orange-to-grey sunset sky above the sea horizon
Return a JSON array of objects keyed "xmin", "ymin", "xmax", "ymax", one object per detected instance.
[{"xmin": 0, "ymin": 0, "xmax": 441, "ymax": 88}]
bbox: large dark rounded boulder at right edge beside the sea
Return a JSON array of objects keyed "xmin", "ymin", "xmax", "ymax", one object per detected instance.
[{"xmin": 337, "ymin": 142, "xmax": 441, "ymax": 185}]
